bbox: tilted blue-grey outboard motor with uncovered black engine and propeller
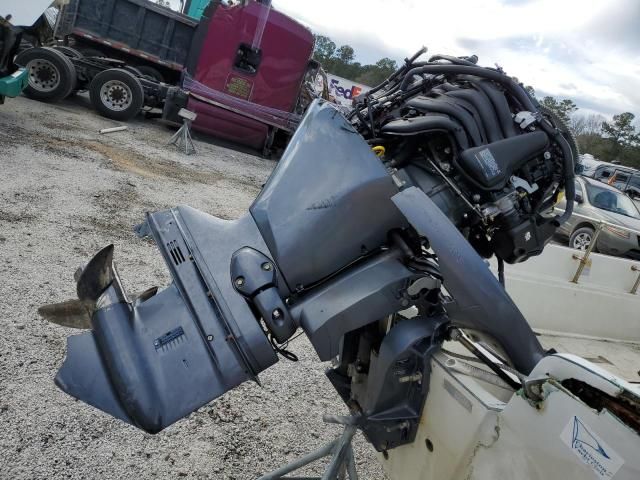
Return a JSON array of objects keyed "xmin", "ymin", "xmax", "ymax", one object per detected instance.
[{"xmin": 40, "ymin": 50, "xmax": 573, "ymax": 450}]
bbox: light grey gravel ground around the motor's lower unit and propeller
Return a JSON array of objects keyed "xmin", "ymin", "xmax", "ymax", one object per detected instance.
[{"xmin": 0, "ymin": 95, "xmax": 384, "ymax": 479}]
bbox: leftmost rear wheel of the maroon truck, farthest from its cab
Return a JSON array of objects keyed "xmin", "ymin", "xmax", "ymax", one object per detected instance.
[{"xmin": 15, "ymin": 47, "xmax": 76, "ymax": 102}]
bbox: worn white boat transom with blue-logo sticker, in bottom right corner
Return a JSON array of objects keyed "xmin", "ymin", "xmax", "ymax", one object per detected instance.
[{"xmin": 380, "ymin": 354, "xmax": 640, "ymax": 480}]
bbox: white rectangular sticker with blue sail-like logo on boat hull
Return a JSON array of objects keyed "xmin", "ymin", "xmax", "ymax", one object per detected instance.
[{"xmin": 560, "ymin": 416, "xmax": 624, "ymax": 479}]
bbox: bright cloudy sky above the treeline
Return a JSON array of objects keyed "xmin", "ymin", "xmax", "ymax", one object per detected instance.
[{"xmin": 174, "ymin": 0, "xmax": 640, "ymax": 117}]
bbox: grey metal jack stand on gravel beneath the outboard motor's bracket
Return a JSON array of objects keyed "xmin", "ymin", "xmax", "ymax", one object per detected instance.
[{"xmin": 258, "ymin": 415, "xmax": 360, "ymax": 480}]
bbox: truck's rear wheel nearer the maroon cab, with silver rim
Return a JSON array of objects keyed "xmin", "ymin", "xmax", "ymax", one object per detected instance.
[{"xmin": 89, "ymin": 68, "xmax": 144, "ymax": 121}]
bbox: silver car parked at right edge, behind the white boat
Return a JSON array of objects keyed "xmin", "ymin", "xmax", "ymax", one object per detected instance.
[{"xmin": 557, "ymin": 177, "xmax": 640, "ymax": 259}]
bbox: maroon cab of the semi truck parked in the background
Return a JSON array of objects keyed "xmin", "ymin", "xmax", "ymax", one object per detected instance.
[{"xmin": 181, "ymin": 1, "xmax": 313, "ymax": 149}]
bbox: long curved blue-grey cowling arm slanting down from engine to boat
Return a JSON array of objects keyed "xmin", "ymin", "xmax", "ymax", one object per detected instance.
[{"xmin": 392, "ymin": 187, "xmax": 544, "ymax": 374}]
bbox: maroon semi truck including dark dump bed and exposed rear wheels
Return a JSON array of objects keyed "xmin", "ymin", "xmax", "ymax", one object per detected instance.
[{"xmin": 15, "ymin": 0, "xmax": 318, "ymax": 153}]
